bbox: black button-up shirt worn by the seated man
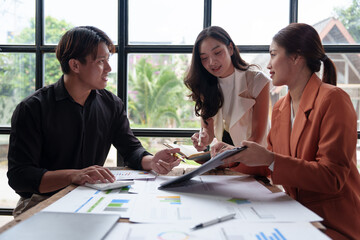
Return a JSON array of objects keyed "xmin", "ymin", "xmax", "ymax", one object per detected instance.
[{"xmin": 7, "ymin": 77, "xmax": 149, "ymax": 198}]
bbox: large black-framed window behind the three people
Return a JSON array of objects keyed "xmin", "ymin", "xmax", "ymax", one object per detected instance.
[{"xmin": 0, "ymin": 0, "xmax": 360, "ymax": 216}]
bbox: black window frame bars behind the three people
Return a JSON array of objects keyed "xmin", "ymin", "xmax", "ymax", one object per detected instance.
[{"xmin": 0, "ymin": 0, "xmax": 360, "ymax": 163}]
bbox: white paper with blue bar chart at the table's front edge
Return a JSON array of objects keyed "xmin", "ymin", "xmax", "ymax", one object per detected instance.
[{"xmin": 105, "ymin": 220, "xmax": 330, "ymax": 240}]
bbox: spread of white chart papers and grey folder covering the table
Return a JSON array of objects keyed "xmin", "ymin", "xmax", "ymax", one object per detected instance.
[{"xmin": 7, "ymin": 172, "xmax": 329, "ymax": 240}]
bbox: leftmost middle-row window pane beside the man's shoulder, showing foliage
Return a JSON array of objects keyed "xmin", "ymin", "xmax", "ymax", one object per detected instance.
[{"xmin": 0, "ymin": 53, "xmax": 35, "ymax": 126}]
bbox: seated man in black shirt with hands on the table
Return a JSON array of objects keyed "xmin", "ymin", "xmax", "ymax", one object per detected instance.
[{"xmin": 7, "ymin": 26, "xmax": 180, "ymax": 215}]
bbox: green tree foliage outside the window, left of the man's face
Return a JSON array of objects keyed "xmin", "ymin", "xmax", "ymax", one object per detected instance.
[{"xmin": 0, "ymin": 17, "xmax": 72, "ymax": 124}]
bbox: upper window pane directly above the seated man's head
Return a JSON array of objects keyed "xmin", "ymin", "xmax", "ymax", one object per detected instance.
[{"xmin": 44, "ymin": 0, "xmax": 118, "ymax": 44}]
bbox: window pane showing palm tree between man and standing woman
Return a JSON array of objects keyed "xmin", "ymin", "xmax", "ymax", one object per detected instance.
[{"xmin": 128, "ymin": 54, "xmax": 200, "ymax": 128}]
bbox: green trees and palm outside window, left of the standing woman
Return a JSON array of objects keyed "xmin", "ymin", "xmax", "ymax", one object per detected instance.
[{"xmin": 0, "ymin": 16, "xmax": 199, "ymax": 128}]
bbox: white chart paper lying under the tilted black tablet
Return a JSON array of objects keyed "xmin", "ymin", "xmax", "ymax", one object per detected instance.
[{"xmin": 130, "ymin": 176, "xmax": 322, "ymax": 223}]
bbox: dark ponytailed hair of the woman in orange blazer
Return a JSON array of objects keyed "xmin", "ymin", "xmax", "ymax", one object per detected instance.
[{"xmin": 273, "ymin": 23, "xmax": 336, "ymax": 86}]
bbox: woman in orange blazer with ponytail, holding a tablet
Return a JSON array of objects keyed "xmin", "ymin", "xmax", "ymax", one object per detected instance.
[{"xmin": 217, "ymin": 23, "xmax": 360, "ymax": 239}]
